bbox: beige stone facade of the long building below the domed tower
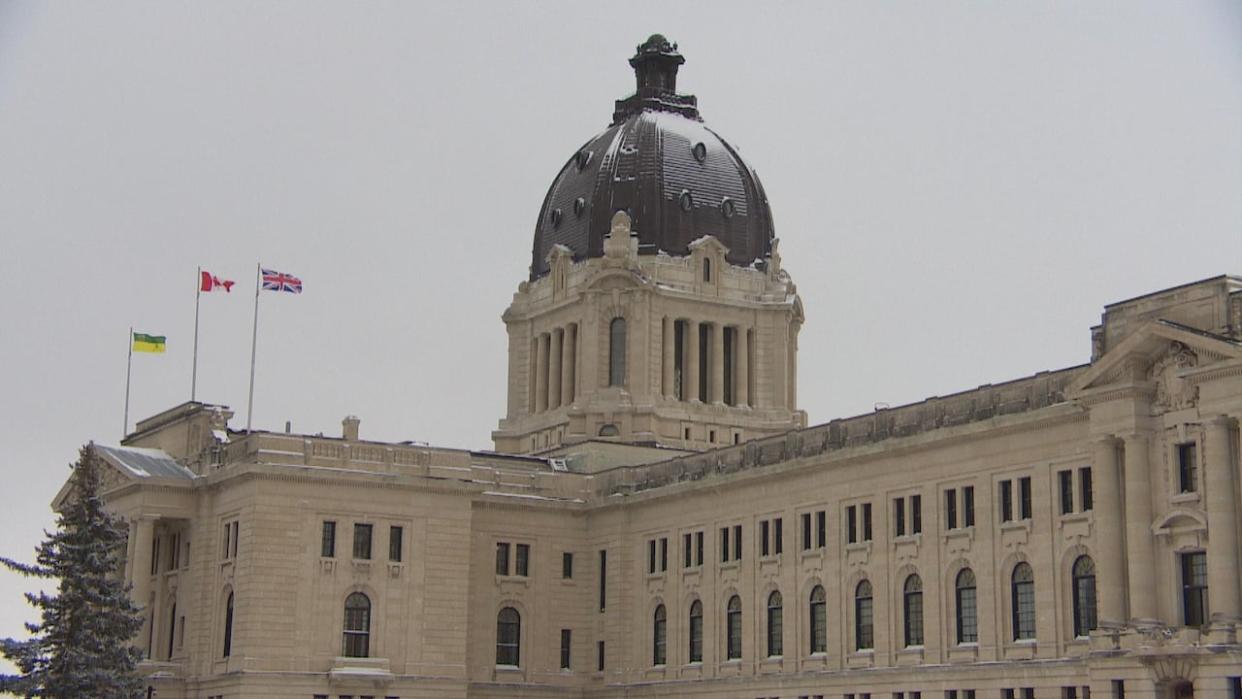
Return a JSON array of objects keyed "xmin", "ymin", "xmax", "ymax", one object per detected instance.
[{"xmin": 70, "ymin": 276, "xmax": 1242, "ymax": 699}]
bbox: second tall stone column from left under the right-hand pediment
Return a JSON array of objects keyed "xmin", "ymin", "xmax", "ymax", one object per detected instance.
[{"xmin": 1125, "ymin": 432, "xmax": 1156, "ymax": 621}]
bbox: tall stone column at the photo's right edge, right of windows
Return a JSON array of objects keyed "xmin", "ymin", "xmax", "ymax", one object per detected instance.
[{"xmin": 1203, "ymin": 415, "xmax": 1242, "ymax": 621}]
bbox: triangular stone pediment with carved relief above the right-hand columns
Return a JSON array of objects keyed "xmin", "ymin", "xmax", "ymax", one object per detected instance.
[{"xmin": 1067, "ymin": 320, "xmax": 1242, "ymax": 404}]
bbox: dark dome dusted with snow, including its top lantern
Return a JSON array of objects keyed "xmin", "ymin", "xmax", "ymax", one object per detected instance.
[{"xmin": 530, "ymin": 34, "xmax": 774, "ymax": 279}]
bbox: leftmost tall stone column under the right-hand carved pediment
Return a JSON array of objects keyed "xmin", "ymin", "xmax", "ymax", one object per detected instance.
[{"xmin": 1092, "ymin": 435, "xmax": 1125, "ymax": 626}]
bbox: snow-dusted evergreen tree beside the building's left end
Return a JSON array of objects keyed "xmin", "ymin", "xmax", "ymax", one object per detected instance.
[{"xmin": 0, "ymin": 444, "xmax": 143, "ymax": 699}]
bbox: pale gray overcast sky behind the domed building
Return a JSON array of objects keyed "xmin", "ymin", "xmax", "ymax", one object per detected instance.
[{"xmin": 0, "ymin": 0, "xmax": 1242, "ymax": 660}]
